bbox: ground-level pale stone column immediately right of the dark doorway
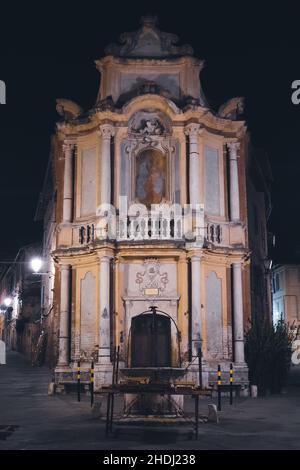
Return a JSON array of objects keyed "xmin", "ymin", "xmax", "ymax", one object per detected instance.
[{"xmin": 191, "ymin": 256, "xmax": 202, "ymax": 358}]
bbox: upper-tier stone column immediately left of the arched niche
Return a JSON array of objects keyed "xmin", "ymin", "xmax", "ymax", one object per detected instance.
[{"xmin": 99, "ymin": 124, "xmax": 114, "ymax": 204}]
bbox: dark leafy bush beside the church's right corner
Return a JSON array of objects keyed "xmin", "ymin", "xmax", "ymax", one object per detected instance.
[{"xmin": 245, "ymin": 315, "xmax": 294, "ymax": 395}]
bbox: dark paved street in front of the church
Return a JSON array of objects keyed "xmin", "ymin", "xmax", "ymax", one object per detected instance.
[{"xmin": 0, "ymin": 352, "xmax": 300, "ymax": 450}]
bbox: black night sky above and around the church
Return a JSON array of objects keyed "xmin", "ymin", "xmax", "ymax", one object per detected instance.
[{"xmin": 0, "ymin": 0, "xmax": 300, "ymax": 261}]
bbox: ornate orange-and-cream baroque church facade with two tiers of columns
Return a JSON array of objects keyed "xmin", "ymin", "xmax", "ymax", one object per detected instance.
[{"xmin": 48, "ymin": 17, "xmax": 251, "ymax": 389}]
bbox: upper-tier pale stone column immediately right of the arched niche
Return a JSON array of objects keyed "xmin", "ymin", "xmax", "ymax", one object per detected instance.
[{"xmin": 185, "ymin": 123, "xmax": 201, "ymax": 206}]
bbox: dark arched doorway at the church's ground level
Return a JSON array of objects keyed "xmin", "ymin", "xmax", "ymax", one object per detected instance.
[{"xmin": 131, "ymin": 313, "xmax": 171, "ymax": 367}]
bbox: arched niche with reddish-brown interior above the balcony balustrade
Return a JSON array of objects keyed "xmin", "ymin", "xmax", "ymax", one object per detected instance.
[{"xmin": 135, "ymin": 148, "xmax": 167, "ymax": 207}]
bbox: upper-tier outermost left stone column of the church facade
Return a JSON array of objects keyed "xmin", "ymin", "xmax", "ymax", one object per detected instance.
[{"xmin": 63, "ymin": 143, "xmax": 74, "ymax": 222}]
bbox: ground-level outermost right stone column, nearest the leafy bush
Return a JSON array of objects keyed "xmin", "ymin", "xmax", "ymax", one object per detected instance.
[{"xmin": 232, "ymin": 263, "xmax": 245, "ymax": 362}]
